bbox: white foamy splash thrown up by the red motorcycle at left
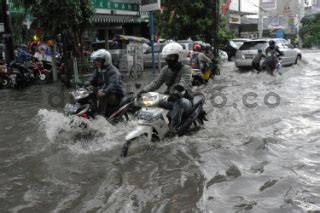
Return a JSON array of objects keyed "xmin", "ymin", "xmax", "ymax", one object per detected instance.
[{"xmin": 38, "ymin": 109, "xmax": 135, "ymax": 154}]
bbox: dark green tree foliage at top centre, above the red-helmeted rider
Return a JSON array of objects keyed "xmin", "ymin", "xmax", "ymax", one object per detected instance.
[{"xmin": 155, "ymin": 0, "xmax": 234, "ymax": 46}]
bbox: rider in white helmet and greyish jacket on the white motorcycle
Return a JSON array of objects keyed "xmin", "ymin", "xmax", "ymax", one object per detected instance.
[{"xmin": 138, "ymin": 42, "xmax": 192, "ymax": 132}]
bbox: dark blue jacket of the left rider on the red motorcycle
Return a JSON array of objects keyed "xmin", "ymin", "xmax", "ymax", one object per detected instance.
[{"xmin": 90, "ymin": 64, "xmax": 124, "ymax": 96}]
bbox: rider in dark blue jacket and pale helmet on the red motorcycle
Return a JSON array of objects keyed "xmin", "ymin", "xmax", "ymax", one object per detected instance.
[{"xmin": 90, "ymin": 49, "xmax": 124, "ymax": 117}]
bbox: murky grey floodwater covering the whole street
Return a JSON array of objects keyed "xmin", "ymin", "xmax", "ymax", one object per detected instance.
[{"xmin": 0, "ymin": 52, "xmax": 320, "ymax": 213}]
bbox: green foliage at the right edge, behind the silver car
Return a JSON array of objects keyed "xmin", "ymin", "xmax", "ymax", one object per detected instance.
[{"xmin": 300, "ymin": 13, "xmax": 320, "ymax": 48}]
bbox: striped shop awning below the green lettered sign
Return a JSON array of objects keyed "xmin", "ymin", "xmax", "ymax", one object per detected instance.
[{"xmin": 93, "ymin": 14, "xmax": 144, "ymax": 24}]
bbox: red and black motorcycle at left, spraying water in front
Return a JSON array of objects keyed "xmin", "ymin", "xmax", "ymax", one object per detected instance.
[{"xmin": 64, "ymin": 87, "xmax": 137, "ymax": 127}]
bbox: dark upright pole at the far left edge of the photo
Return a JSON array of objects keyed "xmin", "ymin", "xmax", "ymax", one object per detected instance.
[{"xmin": 1, "ymin": 0, "xmax": 14, "ymax": 65}]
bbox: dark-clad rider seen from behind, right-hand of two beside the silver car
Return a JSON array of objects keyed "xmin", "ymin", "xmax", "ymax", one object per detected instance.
[{"xmin": 266, "ymin": 40, "xmax": 283, "ymax": 75}]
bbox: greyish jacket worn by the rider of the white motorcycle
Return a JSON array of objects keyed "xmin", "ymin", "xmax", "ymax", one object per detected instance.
[{"xmin": 143, "ymin": 65, "xmax": 192, "ymax": 96}]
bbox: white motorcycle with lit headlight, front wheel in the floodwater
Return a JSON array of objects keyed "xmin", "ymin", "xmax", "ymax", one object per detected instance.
[{"xmin": 120, "ymin": 92, "xmax": 207, "ymax": 157}]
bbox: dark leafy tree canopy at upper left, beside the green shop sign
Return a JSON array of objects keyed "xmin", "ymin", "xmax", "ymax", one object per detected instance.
[{"xmin": 13, "ymin": 0, "xmax": 94, "ymax": 54}]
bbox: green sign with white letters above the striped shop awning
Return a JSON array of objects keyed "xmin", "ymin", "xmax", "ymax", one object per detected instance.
[{"xmin": 92, "ymin": 0, "xmax": 139, "ymax": 12}]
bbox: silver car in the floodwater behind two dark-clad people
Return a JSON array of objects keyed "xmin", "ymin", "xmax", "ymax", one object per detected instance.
[{"xmin": 235, "ymin": 39, "xmax": 302, "ymax": 68}]
